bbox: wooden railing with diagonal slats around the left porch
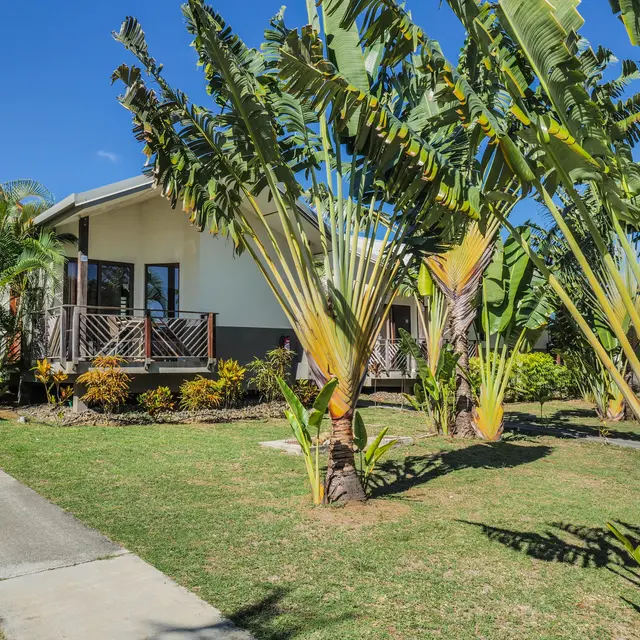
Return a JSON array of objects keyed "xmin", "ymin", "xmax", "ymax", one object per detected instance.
[{"xmin": 28, "ymin": 305, "xmax": 216, "ymax": 366}]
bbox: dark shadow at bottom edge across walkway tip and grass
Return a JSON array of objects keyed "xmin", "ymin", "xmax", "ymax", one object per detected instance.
[{"xmin": 151, "ymin": 587, "xmax": 354, "ymax": 640}]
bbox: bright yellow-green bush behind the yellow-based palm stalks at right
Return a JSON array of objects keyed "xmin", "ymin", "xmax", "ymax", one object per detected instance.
[{"xmin": 467, "ymin": 351, "xmax": 576, "ymax": 402}]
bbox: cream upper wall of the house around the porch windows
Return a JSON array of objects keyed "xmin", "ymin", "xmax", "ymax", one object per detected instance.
[{"xmin": 58, "ymin": 196, "xmax": 289, "ymax": 328}]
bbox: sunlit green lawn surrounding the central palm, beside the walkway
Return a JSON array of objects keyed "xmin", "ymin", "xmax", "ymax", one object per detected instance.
[{"xmin": 0, "ymin": 409, "xmax": 640, "ymax": 640}]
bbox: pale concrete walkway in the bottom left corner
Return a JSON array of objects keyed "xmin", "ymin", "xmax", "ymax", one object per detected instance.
[{"xmin": 0, "ymin": 471, "xmax": 251, "ymax": 640}]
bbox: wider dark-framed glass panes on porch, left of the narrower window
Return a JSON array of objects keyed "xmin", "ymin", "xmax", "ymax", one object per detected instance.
[{"xmin": 63, "ymin": 260, "xmax": 133, "ymax": 313}]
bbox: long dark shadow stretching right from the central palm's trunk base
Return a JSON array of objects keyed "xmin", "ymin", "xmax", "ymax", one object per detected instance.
[{"xmin": 371, "ymin": 442, "xmax": 553, "ymax": 498}]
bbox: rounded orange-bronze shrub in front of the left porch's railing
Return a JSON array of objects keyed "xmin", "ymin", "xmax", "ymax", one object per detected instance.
[{"xmin": 78, "ymin": 356, "xmax": 131, "ymax": 413}]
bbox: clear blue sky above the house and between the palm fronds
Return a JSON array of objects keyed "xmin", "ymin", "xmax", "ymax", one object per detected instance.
[{"xmin": 0, "ymin": 0, "xmax": 640, "ymax": 222}]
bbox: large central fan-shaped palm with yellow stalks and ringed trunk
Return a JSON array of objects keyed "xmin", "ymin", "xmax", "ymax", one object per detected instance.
[{"xmin": 114, "ymin": 0, "xmax": 485, "ymax": 501}]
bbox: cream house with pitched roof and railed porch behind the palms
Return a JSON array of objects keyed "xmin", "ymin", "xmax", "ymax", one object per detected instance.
[{"xmin": 31, "ymin": 176, "xmax": 430, "ymax": 408}]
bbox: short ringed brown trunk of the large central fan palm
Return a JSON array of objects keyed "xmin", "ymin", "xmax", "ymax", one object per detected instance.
[{"xmin": 324, "ymin": 412, "xmax": 367, "ymax": 504}]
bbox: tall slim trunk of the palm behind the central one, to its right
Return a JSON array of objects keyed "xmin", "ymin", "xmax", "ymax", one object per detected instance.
[{"xmin": 450, "ymin": 303, "xmax": 476, "ymax": 438}]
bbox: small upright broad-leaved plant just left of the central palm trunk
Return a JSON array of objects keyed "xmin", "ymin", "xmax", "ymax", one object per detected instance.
[{"xmin": 277, "ymin": 378, "xmax": 338, "ymax": 504}]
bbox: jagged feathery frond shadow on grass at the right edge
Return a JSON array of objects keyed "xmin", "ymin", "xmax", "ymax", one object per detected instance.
[{"xmin": 458, "ymin": 520, "xmax": 640, "ymax": 572}]
